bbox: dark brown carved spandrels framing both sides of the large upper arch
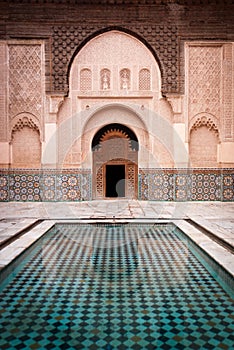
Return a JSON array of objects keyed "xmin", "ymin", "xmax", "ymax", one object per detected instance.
[{"xmin": 52, "ymin": 25, "xmax": 179, "ymax": 94}]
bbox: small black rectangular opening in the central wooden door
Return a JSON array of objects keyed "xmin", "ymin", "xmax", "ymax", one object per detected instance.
[{"xmin": 106, "ymin": 164, "xmax": 125, "ymax": 197}]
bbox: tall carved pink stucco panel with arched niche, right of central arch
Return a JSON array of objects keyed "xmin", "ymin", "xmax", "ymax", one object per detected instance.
[{"xmin": 185, "ymin": 41, "xmax": 234, "ymax": 167}]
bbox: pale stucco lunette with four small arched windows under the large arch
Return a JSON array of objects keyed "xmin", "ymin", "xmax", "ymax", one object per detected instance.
[{"xmin": 69, "ymin": 29, "xmax": 161, "ymax": 94}]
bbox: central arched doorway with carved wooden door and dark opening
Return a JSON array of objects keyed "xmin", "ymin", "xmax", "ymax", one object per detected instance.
[{"xmin": 92, "ymin": 123, "xmax": 139, "ymax": 199}]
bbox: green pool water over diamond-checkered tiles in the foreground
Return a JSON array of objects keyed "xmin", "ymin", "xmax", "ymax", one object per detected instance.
[{"xmin": 0, "ymin": 224, "xmax": 234, "ymax": 350}]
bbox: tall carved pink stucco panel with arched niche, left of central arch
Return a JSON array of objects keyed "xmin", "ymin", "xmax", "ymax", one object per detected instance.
[{"xmin": 0, "ymin": 40, "xmax": 45, "ymax": 168}]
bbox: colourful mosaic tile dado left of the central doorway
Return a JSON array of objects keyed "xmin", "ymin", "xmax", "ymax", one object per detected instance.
[{"xmin": 0, "ymin": 169, "xmax": 91, "ymax": 202}]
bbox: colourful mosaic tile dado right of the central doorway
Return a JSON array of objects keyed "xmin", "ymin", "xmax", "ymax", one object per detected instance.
[{"xmin": 139, "ymin": 169, "xmax": 234, "ymax": 201}]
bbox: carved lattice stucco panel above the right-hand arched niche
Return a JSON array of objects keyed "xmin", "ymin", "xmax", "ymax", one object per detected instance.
[{"xmin": 186, "ymin": 42, "xmax": 234, "ymax": 141}]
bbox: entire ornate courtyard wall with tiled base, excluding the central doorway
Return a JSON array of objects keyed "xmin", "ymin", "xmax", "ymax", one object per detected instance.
[{"xmin": 0, "ymin": 0, "xmax": 234, "ymax": 201}]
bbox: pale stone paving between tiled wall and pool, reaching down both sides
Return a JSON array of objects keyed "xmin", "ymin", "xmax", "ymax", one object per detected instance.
[{"xmin": 0, "ymin": 199, "xmax": 234, "ymax": 243}]
